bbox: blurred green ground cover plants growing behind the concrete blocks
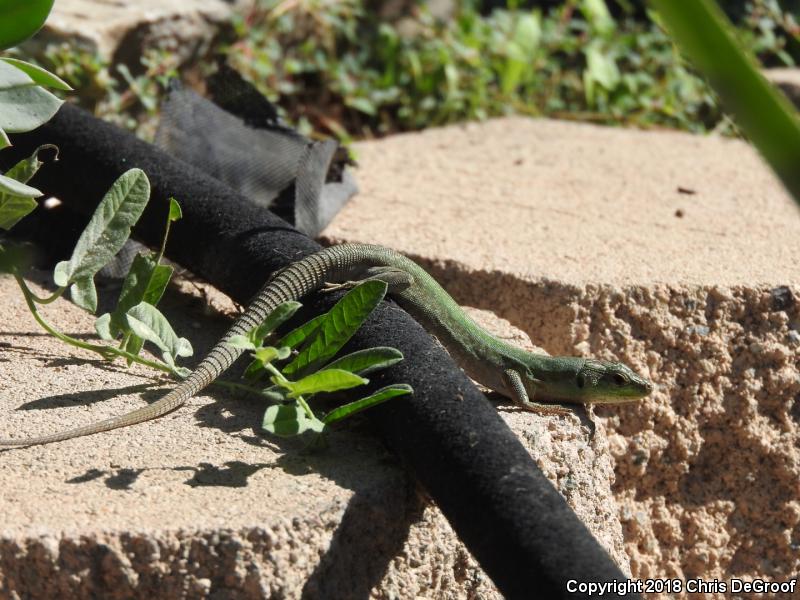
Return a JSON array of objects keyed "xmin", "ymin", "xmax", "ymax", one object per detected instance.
[{"xmin": 17, "ymin": 0, "xmax": 800, "ymax": 140}]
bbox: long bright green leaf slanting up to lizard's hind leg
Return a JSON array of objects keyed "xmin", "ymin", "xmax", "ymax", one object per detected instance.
[{"xmin": 283, "ymin": 280, "xmax": 387, "ymax": 375}]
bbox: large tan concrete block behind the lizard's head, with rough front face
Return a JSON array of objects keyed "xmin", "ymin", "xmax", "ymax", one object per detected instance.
[{"xmin": 324, "ymin": 118, "xmax": 800, "ymax": 597}]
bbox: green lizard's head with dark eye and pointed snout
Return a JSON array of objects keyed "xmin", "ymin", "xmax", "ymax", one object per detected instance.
[{"xmin": 575, "ymin": 359, "xmax": 653, "ymax": 404}]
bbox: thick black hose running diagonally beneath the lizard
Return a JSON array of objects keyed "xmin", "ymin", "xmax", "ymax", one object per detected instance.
[{"xmin": 0, "ymin": 105, "xmax": 638, "ymax": 598}]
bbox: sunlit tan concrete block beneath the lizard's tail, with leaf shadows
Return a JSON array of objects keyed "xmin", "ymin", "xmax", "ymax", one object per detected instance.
[{"xmin": 0, "ymin": 270, "xmax": 629, "ymax": 599}]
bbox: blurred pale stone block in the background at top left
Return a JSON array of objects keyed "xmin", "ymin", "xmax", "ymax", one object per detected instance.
[{"xmin": 18, "ymin": 0, "xmax": 238, "ymax": 69}]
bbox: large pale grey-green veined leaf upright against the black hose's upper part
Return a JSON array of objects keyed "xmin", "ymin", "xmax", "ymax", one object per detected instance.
[{"xmin": 53, "ymin": 169, "xmax": 150, "ymax": 309}]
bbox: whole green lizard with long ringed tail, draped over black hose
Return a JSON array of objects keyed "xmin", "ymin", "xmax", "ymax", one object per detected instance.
[{"xmin": 0, "ymin": 244, "xmax": 652, "ymax": 446}]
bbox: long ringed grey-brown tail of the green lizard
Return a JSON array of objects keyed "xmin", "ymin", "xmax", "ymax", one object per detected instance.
[{"xmin": 0, "ymin": 246, "xmax": 360, "ymax": 446}]
